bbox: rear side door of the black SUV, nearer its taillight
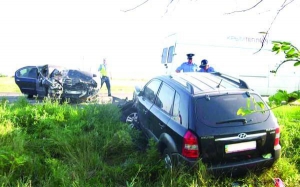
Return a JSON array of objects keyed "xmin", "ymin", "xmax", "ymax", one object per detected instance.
[{"xmin": 149, "ymin": 83, "xmax": 175, "ymax": 140}]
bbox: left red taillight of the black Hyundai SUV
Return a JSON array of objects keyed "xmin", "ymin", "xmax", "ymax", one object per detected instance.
[{"xmin": 182, "ymin": 131, "xmax": 199, "ymax": 158}]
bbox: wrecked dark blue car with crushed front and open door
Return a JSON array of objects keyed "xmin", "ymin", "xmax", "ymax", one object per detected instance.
[{"xmin": 15, "ymin": 65, "xmax": 99, "ymax": 102}]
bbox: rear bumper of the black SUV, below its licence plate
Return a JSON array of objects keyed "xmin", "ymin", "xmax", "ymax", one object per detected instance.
[{"xmin": 173, "ymin": 147, "xmax": 281, "ymax": 173}]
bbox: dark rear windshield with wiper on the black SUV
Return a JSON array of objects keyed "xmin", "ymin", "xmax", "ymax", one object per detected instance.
[{"xmin": 196, "ymin": 93, "xmax": 270, "ymax": 126}]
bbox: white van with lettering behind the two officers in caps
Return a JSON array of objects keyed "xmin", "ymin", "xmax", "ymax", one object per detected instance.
[{"xmin": 161, "ymin": 33, "xmax": 300, "ymax": 96}]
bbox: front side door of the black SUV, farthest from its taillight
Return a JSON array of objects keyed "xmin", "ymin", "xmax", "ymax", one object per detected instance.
[{"xmin": 137, "ymin": 79, "xmax": 161, "ymax": 136}]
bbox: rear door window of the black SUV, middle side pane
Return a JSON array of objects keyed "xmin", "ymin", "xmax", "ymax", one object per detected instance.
[{"xmin": 155, "ymin": 83, "xmax": 175, "ymax": 114}]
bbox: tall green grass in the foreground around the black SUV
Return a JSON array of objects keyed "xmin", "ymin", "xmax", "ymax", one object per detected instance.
[{"xmin": 0, "ymin": 97, "xmax": 300, "ymax": 187}]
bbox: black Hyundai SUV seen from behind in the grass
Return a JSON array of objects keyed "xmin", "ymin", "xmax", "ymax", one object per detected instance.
[{"xmin": 127, "ymin": 72, "xmax": 281, "ymax": 171}]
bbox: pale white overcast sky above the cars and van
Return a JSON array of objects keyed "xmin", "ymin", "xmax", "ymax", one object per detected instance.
[{"xmin": 0, "ymin": 0, "xmax": 300, "ymax": 77}]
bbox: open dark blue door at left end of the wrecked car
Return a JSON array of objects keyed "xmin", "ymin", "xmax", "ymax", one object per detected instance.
[{"xmin": 15, "ymin": 66, "xmax": 38, "ymax": 96}]
